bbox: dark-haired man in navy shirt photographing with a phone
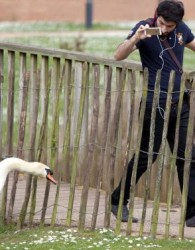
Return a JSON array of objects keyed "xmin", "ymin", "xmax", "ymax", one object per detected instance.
[{"xmin": 111, "ymin": 0, "xmax": 195, "ymax": 227}]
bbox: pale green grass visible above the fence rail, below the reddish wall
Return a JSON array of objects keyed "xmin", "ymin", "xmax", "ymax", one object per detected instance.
[{"xmin": 0, "ymin": 21, "xmax": 195, "ymax": 71}]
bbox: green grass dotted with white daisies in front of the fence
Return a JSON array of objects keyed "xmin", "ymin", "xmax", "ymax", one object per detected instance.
[{"xmin": 0, "ymin": 227, "xmax": 195, "ymax": 250}]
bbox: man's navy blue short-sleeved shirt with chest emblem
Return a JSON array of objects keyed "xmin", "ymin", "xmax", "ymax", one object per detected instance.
[{"xmin": 127, "ymin": 19, "xmax": 194, "ymax": 104}]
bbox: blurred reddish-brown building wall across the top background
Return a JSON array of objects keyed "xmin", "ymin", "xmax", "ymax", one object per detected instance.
[{"xmin": 0, "ymin": 0, "xmax": 195, "ymax": 22}]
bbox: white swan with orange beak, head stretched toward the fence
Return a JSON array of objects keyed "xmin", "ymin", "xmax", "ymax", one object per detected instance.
[{"xmin": 0, "ymin": 157, "xmax": 57, "ymax": 192}]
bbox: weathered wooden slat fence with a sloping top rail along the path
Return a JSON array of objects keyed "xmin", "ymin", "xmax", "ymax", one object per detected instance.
[{"xmin": 0, "ymin": 42, "xmax": 194, "ymax": 237}]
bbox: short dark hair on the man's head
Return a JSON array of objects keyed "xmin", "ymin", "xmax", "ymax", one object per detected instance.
[{"xmin": 156, "ymin": 0, "xmax": 184, "ymax": 24}]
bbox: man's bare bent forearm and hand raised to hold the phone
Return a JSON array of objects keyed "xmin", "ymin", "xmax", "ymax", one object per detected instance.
[{"xmin": 114, "ymin": 24, "xmax": 150, "ymax": 61}]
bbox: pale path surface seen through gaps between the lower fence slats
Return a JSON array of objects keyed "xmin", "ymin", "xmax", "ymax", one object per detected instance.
[{"xmin": 0, "ymin": 175, "xmax": 195, "ymax": 239}]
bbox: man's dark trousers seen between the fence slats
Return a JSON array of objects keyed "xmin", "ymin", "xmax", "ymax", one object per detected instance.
[{"xmin": 112, "ymin": 101, "xmax": 195, "ymax": 219}]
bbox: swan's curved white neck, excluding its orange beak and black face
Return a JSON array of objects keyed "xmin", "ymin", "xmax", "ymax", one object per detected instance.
[{"xmin": 0, "ymin": 157, "xmax": 45, "ymax": 192}]
